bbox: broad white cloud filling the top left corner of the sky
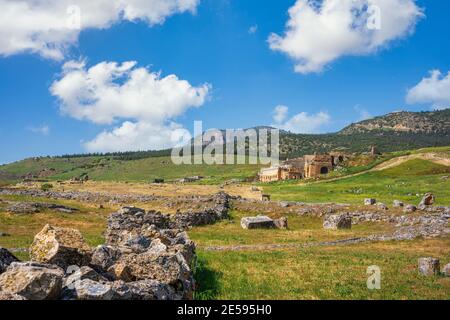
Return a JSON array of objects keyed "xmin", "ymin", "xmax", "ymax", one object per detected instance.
[{"xmin": 0, "ymin": 0, "xmax": 200, "ymax": 59}]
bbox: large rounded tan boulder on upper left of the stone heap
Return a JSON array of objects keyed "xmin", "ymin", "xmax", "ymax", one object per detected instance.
[{"xmin": 30, "ymin": 225, "xmax": 91, "ymax": 269}]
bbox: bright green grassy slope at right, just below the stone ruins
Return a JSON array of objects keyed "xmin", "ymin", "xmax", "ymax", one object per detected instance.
[{"xmin": 264, "ymin": 159, "xmax": 450, "ymax": 205}]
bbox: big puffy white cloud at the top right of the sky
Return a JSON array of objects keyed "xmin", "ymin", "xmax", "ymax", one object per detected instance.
[{"xmin": 269, "ymin": 0, "xmax": 424, "ymax": 74}]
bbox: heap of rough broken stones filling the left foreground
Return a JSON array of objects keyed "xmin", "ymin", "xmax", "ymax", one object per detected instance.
[{"xmin": 0, "ymin": 193, "xmax": 229, "ymax": 300}]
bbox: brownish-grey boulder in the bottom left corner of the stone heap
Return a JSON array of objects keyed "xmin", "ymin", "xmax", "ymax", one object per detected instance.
[{"xmin": 0, "ymin": 262, "xmax": 64, "ymax": 300}]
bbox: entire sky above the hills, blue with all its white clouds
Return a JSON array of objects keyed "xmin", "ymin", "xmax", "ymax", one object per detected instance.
[{"xmin": 0, "ymin": 0, "xmax": 450, "ymax": 163}]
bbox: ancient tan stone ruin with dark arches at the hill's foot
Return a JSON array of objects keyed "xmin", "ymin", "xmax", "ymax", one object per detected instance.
[{"xmin": 259, "ymin": 152, "xmax": 348, "ymax": 182}]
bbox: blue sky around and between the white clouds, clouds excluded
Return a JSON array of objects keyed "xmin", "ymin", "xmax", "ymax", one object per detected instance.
[{"xmin": 0, "ymin": 0, "xmax": 450, "ymax": 163}]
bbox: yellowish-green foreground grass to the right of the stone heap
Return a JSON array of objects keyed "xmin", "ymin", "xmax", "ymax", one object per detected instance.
[{"xmin": 195, "ymin": 238, "xmax": 450, "ymax": 300}]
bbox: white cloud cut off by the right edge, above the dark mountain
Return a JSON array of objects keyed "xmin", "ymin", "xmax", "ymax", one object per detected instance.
[{"xmin": 406, "ymin": 70, "xmax": 450, "ymax": 110}]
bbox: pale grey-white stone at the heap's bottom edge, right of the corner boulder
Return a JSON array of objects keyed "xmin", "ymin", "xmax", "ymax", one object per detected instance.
[{"xmin": 64, "ymin": 279, "xmax": 114, "ymax": 300}]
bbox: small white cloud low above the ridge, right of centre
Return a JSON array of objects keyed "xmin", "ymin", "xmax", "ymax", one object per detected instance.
[{"xmin": 272, "ymin": 106, "xmax": 331, "ymax": 133}]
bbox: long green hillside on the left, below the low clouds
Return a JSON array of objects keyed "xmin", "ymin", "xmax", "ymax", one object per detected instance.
[{"xmin": 0, "ymin": 157, "xmax": 261, "ymax": 184}]
